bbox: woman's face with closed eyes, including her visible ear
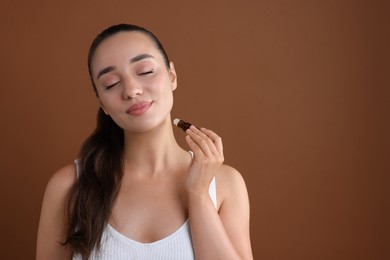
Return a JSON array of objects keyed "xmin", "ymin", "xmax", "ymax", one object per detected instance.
[{"xmin": 91, "ymin": 32, "xmax": 177, "ymax": 133}]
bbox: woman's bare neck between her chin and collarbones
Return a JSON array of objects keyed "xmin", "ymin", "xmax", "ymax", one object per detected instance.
[{"xmin": 124, "ymin": 118, "xmax": 183, "ymax": 175}]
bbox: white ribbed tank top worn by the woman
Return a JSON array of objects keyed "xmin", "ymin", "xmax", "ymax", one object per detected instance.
[{"xmin": 72, "ymin": 160, "xmax": 217, "ymax": 260}]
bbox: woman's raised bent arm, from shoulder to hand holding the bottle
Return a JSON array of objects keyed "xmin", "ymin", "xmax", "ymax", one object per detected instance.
[{"xmin": 187, "ymin": 127, "xmax": 253, "ymax": 260}]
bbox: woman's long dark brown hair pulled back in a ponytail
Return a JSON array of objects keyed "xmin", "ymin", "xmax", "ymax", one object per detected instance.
[{"xmin": 63, "ymin": 24, "xmax": 169, "ymax": 259}]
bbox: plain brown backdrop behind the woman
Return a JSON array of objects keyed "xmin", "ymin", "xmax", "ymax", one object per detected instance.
[{"xmin": 0, "ymin": 0, "xmax": 390, "ymax": 260}]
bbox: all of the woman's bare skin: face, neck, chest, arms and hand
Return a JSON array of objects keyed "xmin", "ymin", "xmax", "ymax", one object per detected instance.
[{"xmin": 37, "ymin": 32, "xmax": 253, "ymax": 260}]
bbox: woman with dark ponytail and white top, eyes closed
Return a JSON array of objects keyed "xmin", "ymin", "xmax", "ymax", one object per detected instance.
[{"xmin": 37, "ymin": 24, "xmax": 253, "ymax": 260}]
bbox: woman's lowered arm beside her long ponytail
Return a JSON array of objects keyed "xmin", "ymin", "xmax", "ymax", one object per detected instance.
[{"xmin": 36, "ymin": 165, "xmax": 76, "ymax": 260}]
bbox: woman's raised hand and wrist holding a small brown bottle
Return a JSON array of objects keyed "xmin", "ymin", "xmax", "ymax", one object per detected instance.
[{"xmin": 186, "ymin": 126, "xmax": 224, "ymax": 195}]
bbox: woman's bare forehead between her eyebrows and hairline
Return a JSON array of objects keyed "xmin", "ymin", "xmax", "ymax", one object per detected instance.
[{"xmin": 91, "ymin": 32, "xmax": 162, "ymax": 71}]
